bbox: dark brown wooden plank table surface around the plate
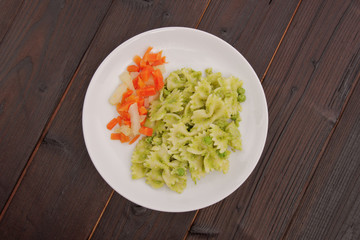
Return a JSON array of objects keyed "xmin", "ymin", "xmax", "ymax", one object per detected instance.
[{"xmin": 0, "ymin": 0, "xmax": 360, "ymax": 239}]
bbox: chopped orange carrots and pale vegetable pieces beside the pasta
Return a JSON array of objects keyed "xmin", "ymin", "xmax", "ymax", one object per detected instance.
[{"xmin": 106, "ymin": 47, "xmax": 166, "ymax": 144}]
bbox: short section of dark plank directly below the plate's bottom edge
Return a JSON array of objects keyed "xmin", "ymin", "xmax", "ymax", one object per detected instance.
[{"xmin": 91, "ymin": 194, "xmax": 194, "ymax": 240}]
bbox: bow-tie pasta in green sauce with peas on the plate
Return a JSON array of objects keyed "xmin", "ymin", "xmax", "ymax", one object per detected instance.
[{"xmin": 131, "ymin": 68, "xmax": 246, "ymax": 193}]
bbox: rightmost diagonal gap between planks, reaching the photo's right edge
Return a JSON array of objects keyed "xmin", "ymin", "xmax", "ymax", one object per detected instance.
[{"xmin": 281, "ymin": 73, "xmax": 360, "ymax": 239}]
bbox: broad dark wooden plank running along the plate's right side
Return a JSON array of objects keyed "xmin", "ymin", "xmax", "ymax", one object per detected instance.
[{"xmin": 189, "ymin": 0, "xmax": 359, "ymax": 239}]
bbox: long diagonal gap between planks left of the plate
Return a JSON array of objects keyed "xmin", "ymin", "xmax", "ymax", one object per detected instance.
[{"xmin": 0, "ymin": 0, "xmax": 114, "ymax": 222}]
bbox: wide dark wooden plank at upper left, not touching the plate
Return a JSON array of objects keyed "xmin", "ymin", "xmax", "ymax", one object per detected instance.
[{"xmin": 0, "ymin": 0, "xmax": 111, "ymax": 209}]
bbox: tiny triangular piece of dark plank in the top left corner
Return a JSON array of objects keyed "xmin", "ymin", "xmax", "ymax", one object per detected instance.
[{"xmin": 0, "ymin": 0, "xmax": 23, "ymax": 41}]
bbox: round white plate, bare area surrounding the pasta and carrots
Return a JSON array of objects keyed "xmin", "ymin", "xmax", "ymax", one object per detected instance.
[{"xmin": 82, "ymin": 27, "xmax": 268, "ymax": 212}]
